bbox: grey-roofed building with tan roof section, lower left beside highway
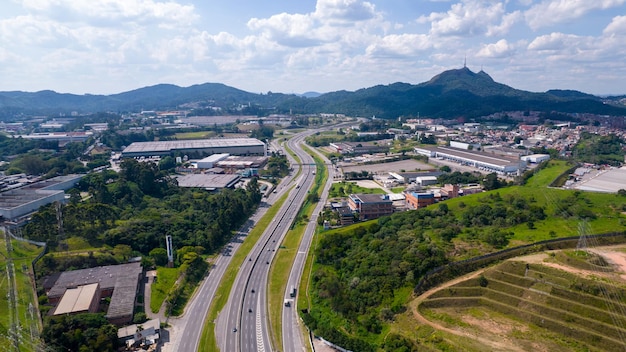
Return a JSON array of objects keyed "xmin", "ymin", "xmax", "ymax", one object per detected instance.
[{"xmin": 44, "ymin": 263, "xmax": 143, "ymax": 325}]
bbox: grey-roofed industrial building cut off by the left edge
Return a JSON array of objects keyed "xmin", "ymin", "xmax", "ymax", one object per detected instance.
[{"xmin": 0, "ymin": 175, "xmax": 84, "ymax": 220}]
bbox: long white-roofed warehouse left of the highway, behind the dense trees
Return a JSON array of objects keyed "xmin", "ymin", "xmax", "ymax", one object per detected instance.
[{"xmin": 122, "ymin": 138, "xmax": 266, "ymax": 158}]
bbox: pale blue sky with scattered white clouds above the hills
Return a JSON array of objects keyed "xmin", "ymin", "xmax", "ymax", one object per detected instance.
[{"xmin": 0, "ymin": 0, "xmax": 626, "ymax": 95}]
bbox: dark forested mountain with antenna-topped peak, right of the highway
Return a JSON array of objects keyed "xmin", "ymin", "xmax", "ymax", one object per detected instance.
[{"xmin": 294, "ymin": 68, "xmax": 626, "ymax": 118}]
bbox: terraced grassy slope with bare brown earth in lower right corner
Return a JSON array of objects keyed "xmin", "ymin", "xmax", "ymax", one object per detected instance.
[{"xmin": 417, "ymin": 247, "xmax": 626, "ymax": 351}]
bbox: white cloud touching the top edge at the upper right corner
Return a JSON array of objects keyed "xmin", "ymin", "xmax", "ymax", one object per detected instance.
[{"xmin": 524, "ymin": 0, "xmax": 626, "ymax": 29}]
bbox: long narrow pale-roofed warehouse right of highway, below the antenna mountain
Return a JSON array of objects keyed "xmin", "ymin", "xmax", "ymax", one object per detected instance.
[{"xmin": 414, "ymin": 147, "xmax": 526, "ymax": 175}]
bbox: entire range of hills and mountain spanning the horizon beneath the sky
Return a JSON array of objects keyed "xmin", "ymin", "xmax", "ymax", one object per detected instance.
[{"xmin": 0, "ymin": 67, "xmax": 626, "ymax": 119}]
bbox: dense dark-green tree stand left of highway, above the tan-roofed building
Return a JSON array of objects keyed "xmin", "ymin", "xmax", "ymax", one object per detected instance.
[{"xmin": 24, "ymin": 159, "xmax": 261, "ymax": 255}]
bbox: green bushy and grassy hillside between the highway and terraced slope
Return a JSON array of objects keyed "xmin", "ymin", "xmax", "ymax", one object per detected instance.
[{"xmin": 303, "ymin": 161, "xmax": 626, "ymax": 351}]
